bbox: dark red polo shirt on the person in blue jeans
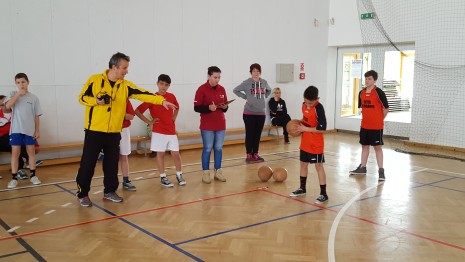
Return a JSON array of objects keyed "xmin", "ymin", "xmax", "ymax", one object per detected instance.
[{"xmin": 194, "ymin": 81, "xmax": 228, "ymax": 131}]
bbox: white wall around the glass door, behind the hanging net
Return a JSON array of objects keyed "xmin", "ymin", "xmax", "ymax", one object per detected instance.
[{"xmin": 328, "ymin": 0, "xmax": 465, "ymax": 148}]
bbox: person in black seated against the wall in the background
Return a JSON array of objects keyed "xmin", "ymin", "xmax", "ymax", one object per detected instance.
[{"xmin": 268, "ymin": 87, "xmax": 291, "ymax": 144}]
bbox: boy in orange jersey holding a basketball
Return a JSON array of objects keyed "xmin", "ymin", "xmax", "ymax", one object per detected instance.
[{"xmin": 290, "ymin": 86, "xmax": 329, "ymax": 204}]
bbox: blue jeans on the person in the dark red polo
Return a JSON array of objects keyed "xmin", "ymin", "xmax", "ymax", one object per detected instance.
[{"xmin": 200, "ymin": 130, "xmax": 226, "ymax": 170}]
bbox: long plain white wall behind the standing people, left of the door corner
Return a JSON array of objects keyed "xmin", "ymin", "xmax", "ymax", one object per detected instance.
[{"xmin": 0, "ymin": 0, "xmax": 331, "ymax": 151}]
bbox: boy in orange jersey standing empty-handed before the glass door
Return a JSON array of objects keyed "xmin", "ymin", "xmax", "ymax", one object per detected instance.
[{"xmin": 350, "ymin": 70, "xmax": 389, "ymax": 181}]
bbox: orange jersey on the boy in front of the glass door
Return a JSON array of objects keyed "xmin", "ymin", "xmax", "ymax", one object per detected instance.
[{"xmin": 358, "ymin": 86, "xmax": 389, "ymax": 130}]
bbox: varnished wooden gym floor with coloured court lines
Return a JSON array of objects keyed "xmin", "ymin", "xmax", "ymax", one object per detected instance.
[{"xmin": 0, "ymin": 133, "xmax": 465, "ymax": 261}]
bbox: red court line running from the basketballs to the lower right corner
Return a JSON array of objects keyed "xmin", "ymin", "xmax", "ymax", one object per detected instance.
[{"xmin": 260, "ymin": 190, "xmax": 465, "ymax": 251}]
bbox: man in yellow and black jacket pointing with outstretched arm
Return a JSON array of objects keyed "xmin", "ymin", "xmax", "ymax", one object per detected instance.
[{"xmin": 76, "ymin": 53, "xmax": 176, "ymax": 207}]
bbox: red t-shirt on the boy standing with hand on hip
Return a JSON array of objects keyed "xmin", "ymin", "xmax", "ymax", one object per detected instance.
[{"xmin": 137, "ymin": 92, "xmax": 179, "ymax": 135}]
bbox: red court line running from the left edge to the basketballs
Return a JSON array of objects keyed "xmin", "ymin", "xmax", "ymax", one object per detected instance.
[{"xmin": 0, "ymin": 189, "xmax": 262, "ymax": 241}]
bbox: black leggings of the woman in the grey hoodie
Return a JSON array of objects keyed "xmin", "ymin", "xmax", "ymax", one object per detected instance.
[{"xmin": 242, "ymin": 114, "xmax": 266, "ymax": 154}]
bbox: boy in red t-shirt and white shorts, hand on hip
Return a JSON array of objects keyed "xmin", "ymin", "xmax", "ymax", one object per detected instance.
[{"xmin": 136, "ymin": 74, "xmax": 186, "ymax": 187}]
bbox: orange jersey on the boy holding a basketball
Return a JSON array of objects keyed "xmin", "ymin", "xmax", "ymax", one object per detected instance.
[{"xmin": 300, "ymin": 102, "xmax": 326, "ymax": 155}]
